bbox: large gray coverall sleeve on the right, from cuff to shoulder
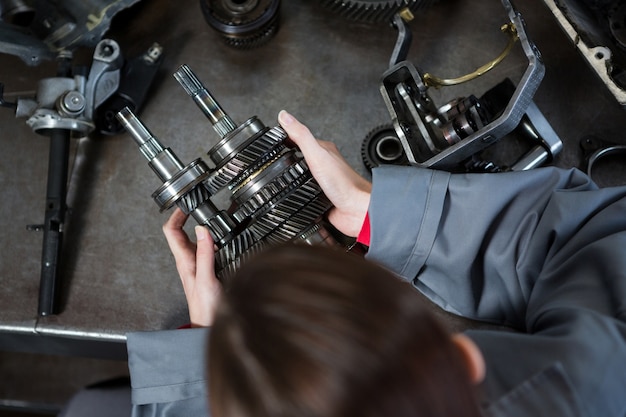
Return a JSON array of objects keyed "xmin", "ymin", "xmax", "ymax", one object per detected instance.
[{"xmin": 368, "ymin": 167, "xmax": 626, "ymax": 417}]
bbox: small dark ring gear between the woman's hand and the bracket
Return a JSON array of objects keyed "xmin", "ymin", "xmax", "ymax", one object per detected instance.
[{"xmin": 361, "ymin": 125, "xmax": 408, "ymax": 171}]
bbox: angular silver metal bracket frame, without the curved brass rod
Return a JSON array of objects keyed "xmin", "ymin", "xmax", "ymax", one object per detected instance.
[{"xmin": 380, "ymin": 0, "xmax": 545, "ymax": 169}]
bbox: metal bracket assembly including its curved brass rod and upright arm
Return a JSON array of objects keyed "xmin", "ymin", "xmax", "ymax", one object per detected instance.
[{"xmin": 380, "ymin": 0, "xmax": 560, "ymax": 169}]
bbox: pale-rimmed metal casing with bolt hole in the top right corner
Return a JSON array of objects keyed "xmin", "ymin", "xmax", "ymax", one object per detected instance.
[{"xmin": 543, "ymin": 0, "xmax": 626, "ymax": 107}]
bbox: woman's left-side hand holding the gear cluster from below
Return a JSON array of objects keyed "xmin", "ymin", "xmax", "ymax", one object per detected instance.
[{"xmin": 163, "ymin": 208, "xmax": 222, "ymax": 327}]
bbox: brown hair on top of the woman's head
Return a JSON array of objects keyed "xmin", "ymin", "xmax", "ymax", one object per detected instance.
[{"xmin": 209, "ymin": 245, "xmax": 479, "ymax": 417}]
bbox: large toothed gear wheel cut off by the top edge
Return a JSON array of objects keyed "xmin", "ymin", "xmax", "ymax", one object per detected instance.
[{"xmin": 320, "ymin": 0, "xmax": 437, "ymax": 23}]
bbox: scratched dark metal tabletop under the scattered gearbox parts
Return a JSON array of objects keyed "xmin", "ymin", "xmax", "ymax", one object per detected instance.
[{"xmin": 0, "ymin": 0, "xmax": 626, "ymax": 358}]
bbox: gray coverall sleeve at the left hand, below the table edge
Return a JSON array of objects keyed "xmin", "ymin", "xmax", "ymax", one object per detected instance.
[{"xmin": 127, "ymin": 328, "xmax": 209, "ymax": 417}]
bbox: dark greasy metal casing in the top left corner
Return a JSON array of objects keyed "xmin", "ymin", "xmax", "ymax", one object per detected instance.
[{"xmin": 0, "ymin": 0, "xmax": 139, "ymax": 65}]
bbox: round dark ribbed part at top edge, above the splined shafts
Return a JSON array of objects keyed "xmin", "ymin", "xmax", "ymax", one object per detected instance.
[{"xmin": 200, "ymin": 0, "xmax": 280, "ymax": 49}]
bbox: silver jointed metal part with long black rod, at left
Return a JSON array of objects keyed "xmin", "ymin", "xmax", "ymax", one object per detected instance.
[{"xmin": 0, "ymin": 39, "xmax": 123, "ymax": 316}]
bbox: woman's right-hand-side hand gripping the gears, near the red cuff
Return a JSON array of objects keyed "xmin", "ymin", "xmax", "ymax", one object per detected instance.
[{"xmin": 278, "ymin": 110, "xmax": 372, "ymax": 237}]
